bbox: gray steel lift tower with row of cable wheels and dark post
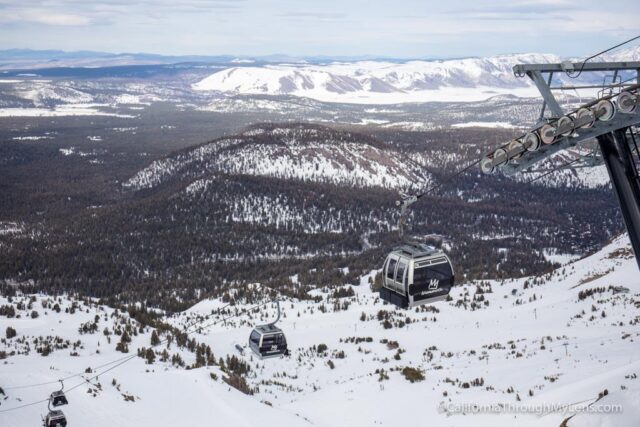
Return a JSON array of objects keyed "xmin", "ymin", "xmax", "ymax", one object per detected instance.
[{"xmin": 480, "ymin": 62, "xmax": 640, "ymax": 268}]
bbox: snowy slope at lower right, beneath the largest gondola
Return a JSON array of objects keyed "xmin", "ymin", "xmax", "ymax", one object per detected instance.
[{"xmin": 176, "ymin": 239, "xmax": 640, "ymax": 426}]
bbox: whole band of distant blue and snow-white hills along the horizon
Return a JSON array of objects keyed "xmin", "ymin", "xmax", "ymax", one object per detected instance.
[{"xmin": 0, "ymin": 47, "xmax": 640, "ymax": 104}]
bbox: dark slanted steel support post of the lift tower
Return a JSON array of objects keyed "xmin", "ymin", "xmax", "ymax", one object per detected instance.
[{"xmin": 598, "ymin": 129, "xmax": 640, "ymax": 268}]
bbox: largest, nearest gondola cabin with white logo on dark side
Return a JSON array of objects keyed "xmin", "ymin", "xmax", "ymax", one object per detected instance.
[{"xmin": 380, "ymin": 243, "xmax": 454, "ymax": 308}]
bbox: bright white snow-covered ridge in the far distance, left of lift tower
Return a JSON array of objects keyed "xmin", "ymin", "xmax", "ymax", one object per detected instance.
[{"xmin": 193, "ymin": 54, "xmax": 559, "ymax": 104}]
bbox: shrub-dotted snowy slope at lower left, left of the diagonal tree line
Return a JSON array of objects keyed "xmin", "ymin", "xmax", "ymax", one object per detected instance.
[{"xmin": 0, "ymin": 296, "xmax": 305, "ymax": 427}]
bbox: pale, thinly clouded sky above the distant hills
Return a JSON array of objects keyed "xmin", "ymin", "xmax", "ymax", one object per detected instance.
[{"xmin": 0, "ymin": 0, "xmax": 640, "ymax": 58}]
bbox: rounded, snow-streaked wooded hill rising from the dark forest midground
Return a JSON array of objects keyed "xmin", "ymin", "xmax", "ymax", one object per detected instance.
[{"xmin": 124, "ymin": 124, "xmax": 430, "ymax": 192}]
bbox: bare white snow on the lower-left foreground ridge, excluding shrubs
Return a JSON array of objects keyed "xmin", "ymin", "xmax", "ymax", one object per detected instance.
[{"xmin": 0, "ymin": 300, "xmax": 306, "ymax": 427}]
